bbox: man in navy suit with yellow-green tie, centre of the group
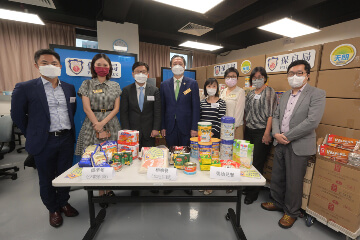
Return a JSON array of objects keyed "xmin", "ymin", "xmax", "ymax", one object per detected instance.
[{"xmin": 160, "ymin": 55, "xmax": 200, "ymax": 147}]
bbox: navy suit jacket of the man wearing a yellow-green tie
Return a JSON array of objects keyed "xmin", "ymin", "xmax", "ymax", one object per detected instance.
[{"xmin": 160, "ymin": 76, "xmax": 200, "ymax": 135}]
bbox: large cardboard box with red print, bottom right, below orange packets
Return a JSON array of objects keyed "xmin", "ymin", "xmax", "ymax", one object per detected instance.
[{"xmin": 308, "ymin": 156, "xmax": 360, "ymax": 233}]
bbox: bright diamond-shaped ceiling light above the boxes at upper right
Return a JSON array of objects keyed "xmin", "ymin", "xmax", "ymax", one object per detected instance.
[{"xmin": 259, "ymin": 18, "xmax": 320, "ymax": 38}]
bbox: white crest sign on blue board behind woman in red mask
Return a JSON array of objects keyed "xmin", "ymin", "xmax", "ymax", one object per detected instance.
[{"xmin": 65, "ymin": 58, "xmax": 121, "ymax": 78}]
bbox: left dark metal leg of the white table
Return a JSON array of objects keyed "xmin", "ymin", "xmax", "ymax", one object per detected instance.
[{"xmin": 83, "ymin": 190, "xmax": 106, "ymax": 240}]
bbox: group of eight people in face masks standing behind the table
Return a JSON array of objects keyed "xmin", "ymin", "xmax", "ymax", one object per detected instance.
[{"xmin": 11, "ymin": 49, "xmax": 325, "ymax": 227}]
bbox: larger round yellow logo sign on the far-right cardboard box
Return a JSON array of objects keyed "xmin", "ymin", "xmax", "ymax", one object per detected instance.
[{"xmin": 330, "ymin": 44, "xmax": 356, "ymax": 66}]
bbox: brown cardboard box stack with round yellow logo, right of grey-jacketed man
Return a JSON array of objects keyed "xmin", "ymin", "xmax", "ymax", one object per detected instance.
[{"xmin": 316, "ymin": 38, "xmax": 360, "ymax": 138}]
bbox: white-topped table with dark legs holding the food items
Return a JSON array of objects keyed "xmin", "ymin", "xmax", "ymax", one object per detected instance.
[{"xmin": 52, "ymin": 160, "xmax": 266, "ymax": 240}]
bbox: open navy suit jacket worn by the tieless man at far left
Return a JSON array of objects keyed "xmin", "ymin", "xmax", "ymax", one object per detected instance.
[{"xmin": 11, "ymin": 78, "xmax": 76, "ymax": 155}]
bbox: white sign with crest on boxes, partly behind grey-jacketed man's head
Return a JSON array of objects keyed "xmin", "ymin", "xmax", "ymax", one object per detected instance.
[{"xmin": 265, "ymin": 49, "xmax": 316, "ymax": 72}]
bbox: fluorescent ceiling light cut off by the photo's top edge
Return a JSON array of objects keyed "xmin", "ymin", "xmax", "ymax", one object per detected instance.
[{"xmin": 153, "ymin": 0, "xmax": 224, "ymax": 13}]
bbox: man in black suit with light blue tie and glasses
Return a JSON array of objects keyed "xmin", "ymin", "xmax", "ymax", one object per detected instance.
[{"xmin": 120, "ymin": 62, "xmax": 161, "ymax": 149}]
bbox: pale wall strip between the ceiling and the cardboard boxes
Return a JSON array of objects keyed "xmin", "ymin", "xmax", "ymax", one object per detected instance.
[{"xmin": 216, "ymin": 18, "xmax": 360, "ymax": 63}]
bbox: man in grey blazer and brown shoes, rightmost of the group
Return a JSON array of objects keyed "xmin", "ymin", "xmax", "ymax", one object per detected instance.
[{"xmin": 261, "ymin": 60, "xmax": 326, "ymax": 228}]
